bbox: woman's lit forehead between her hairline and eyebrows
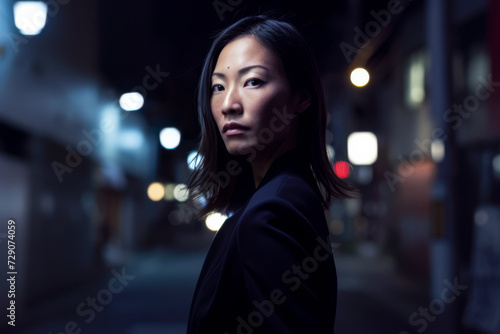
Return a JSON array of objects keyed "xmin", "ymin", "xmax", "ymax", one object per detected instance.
[{"xmin": 214, "ymin": 36, "xmax": 281, "ymax": 72}]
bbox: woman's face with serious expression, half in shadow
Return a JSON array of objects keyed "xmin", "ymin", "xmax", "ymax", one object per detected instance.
[{"xmin": 211, "ymin": 36, "xmax": 303, "ymax": 158}]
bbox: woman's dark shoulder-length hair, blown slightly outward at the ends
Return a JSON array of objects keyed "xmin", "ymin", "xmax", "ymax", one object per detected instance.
[{"xmin": 187, "ymin": 15, "xmax": 356, "ymax": 217}]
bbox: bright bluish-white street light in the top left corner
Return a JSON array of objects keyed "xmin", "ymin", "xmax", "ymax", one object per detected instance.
[{"xmin": 14, "ymin": 1, "xmax": 47, "ymax": 36}]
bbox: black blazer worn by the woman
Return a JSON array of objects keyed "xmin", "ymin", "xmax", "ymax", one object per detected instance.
[{"xmin": 188, "ymin": 150, "xmax": 337, "ymax": 334}]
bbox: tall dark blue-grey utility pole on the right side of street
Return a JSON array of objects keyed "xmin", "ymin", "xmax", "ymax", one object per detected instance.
[{"xmin": 426, "ymin": 0, "xmax": 458, "ymax": 334}]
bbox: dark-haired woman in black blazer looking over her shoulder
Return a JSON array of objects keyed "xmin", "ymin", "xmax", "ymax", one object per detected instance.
[{"xmin": 188, "ymin": 16, "xmax": 353, "ymax": 334}]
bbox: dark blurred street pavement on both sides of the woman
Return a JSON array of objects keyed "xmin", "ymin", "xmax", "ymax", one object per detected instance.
[{"xmin": 10, "ymin": 243, "xmax": 439, "ymax": 334}]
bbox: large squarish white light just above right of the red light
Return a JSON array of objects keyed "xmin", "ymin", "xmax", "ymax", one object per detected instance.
[{"xmin": 347, "ymin": 132, "xmax": 378, "ymax": 165}]
